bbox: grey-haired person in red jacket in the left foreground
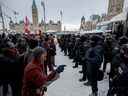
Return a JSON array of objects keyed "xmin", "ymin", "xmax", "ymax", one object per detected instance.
[{"xmin": 22, "ymin": 47, "xmax": 59, "ymax": 96}]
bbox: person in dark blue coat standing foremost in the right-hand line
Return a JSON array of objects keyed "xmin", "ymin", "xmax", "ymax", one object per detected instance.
[{"xmin": 86, "ymin": 35, "xmax": 103, "ymax": 96}]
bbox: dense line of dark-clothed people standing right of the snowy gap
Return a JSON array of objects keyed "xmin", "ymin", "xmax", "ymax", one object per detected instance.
[{"xmin": 58, "ymin": 27, "xmax": 128, "ymax": 96}]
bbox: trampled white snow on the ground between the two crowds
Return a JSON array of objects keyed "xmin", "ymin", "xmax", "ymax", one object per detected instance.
[{"xmin": 47, "ymin": 47, "xmax": 108, "ymax": 96}]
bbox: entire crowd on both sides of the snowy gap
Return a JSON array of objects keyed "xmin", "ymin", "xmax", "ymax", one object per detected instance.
[{"xmin": 0, "ymin": 21, "xmax": 128, "ymax": 96}]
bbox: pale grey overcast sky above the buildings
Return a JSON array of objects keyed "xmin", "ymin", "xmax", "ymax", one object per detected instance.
[{"xmin": 0, "ymin": 0, "xmax": 128, "ymax": 29}]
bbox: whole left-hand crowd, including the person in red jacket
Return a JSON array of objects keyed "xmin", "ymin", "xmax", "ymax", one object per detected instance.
[{"xmin": 0, "ymin": 33, "xmax": 65, "ymax": 96}]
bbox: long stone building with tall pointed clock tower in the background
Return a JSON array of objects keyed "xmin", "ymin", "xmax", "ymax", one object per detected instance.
[{"xmin": 9, "ymin": 0, "xmax": 62, "ymax": 32}]
